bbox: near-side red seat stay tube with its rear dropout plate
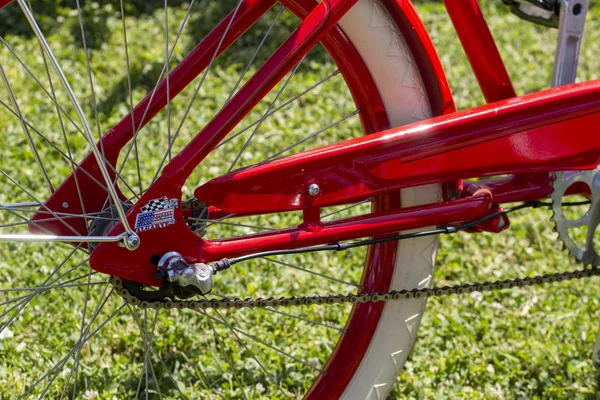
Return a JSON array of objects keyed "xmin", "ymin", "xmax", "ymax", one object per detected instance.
[{"xmin": 90, "ymin": 0, "xmax": 353, "ymax": 286}]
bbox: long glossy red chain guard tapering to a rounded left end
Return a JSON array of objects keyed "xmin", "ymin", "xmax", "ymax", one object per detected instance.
[{"xmin": 195, "ymin": 81, "xmax": 600, "ymax": 212}]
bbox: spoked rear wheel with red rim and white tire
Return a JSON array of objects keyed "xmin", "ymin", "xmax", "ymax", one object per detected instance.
[{"xmin": 0, "ymin": 0, "xmax": 440, "ymax": 399}]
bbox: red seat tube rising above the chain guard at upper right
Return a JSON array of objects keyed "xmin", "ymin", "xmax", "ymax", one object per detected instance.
[{"xmin": 444, "ymin": 0, "xmax": 516, "ymax": 103}]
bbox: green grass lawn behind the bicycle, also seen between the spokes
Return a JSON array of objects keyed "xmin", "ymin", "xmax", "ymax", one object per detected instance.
[{"xmin": 0, "ymin": 0, "xmax": 600, "ymax": 399}]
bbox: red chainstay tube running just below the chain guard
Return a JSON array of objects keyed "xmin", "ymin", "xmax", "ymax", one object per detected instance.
[{"xmin": 201, "ymin": 190, "xmax": 493, "ymax": 262}]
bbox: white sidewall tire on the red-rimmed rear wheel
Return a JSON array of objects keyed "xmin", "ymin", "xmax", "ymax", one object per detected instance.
[{"xmin": 332, "ymin": 0, "xmax": 441, "ymax": 400}]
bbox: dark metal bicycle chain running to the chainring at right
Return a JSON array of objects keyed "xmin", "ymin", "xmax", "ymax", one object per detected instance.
[{"xmin": 112, "ymin": 267, "xmax": 600, "ymax": 310}]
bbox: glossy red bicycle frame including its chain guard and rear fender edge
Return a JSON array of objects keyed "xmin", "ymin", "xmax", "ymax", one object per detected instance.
[{"xmin": 0, "ymin": 0, "xmax": 600, "ymax": 286}]
